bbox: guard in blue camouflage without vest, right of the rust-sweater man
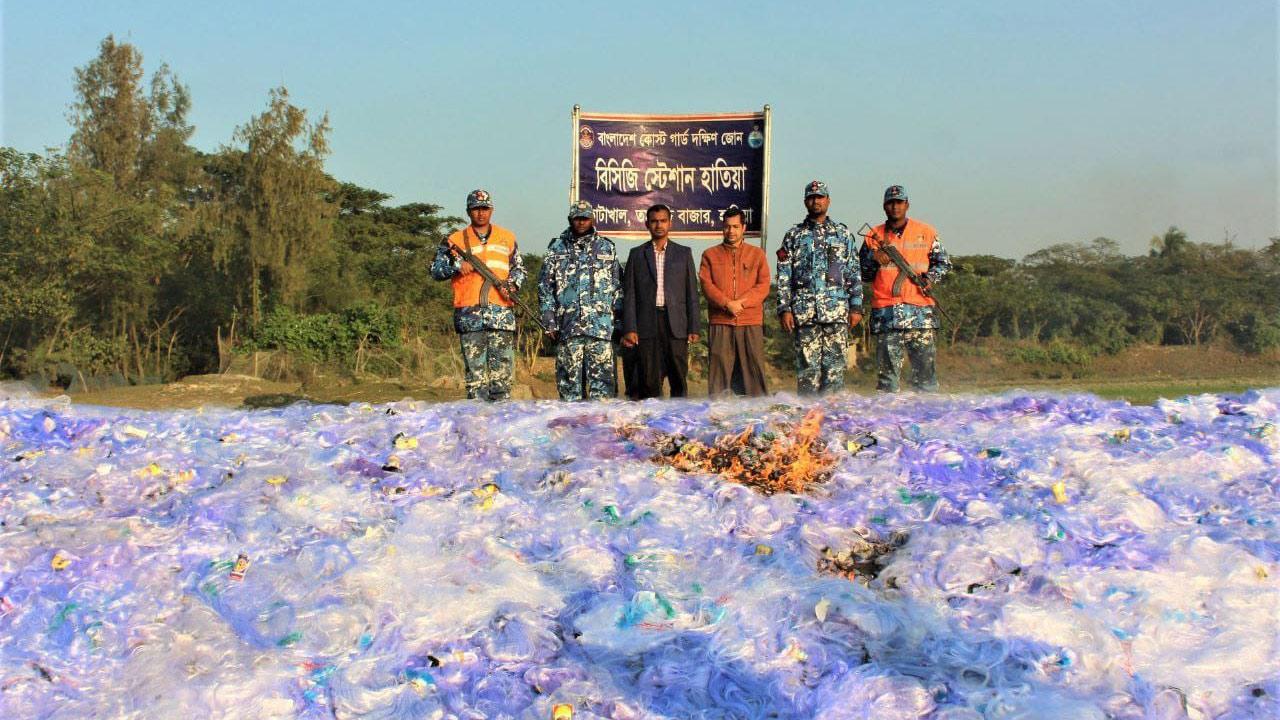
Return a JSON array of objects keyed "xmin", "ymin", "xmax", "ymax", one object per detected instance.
[{"xmin": 778, "ymin": 181, "xmax": 863, "ymax": 395}]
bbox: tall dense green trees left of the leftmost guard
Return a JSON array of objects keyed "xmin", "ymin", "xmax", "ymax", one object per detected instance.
[{"xmin": 0, "ymin": 37, "xmax": 488, "ymax": 382}]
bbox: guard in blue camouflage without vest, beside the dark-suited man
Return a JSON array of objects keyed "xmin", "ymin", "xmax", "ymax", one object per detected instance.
[{"xmin": 538, "ymin": 200, "xmax": 622, "ymax": 400}]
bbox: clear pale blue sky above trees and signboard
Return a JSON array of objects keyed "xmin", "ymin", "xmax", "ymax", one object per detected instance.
[{"xmin": 0, "ymin": 0, "xmax": 1280, "ymax": 258}]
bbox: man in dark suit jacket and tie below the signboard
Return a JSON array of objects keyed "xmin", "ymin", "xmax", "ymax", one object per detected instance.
[{"xmin": 622, "ymin": 205, "xmax": 701, "ymax": 400}]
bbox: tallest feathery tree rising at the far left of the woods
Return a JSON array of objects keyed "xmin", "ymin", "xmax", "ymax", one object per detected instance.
[{"xmin": 59, "ymin": 36, "xmax": 202, "ymax": 375}]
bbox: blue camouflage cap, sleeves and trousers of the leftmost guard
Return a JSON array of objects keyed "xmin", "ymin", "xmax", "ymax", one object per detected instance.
[{"xmin": 431, "ymin": 191, "xmax": 527, "ymax": 402}]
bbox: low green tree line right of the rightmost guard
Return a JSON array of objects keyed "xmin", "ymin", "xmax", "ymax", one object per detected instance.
[{"xmin": 938, "ymin": 227, "xmax": 1280, "ymax": 354}]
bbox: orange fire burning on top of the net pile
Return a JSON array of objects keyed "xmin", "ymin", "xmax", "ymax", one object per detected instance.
[{"xmin": 620, "ymin": 407, "xmax": 836, "ymax": 495}]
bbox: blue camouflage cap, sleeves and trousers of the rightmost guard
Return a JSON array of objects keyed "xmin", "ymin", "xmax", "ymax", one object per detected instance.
[{"xmin": 859, "ymin": 186, "xmax": 951, "ymax": 392}]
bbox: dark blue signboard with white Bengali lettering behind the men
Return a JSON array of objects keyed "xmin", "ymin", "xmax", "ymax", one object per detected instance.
[{"xmin": 570, "ymin": 106, "xmax": 769, "ymax": 245}]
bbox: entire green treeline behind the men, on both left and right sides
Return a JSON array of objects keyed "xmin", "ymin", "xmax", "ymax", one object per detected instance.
[{"xmin": 0, "ymin": 37, "xmax": 1280, "ymax": 382}]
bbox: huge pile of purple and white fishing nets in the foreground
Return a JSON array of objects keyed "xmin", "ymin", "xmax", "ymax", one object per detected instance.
[{"xmin": 0, "ymin": 389, "xmax": 1280, "ymax": 720}]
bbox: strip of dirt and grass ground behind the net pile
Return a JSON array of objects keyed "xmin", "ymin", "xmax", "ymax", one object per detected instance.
[{"xmin": 47, "ymin": 347, "xmax": 1280, "ymax": 410}]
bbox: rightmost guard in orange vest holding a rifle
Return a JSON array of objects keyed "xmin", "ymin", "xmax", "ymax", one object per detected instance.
[{"xmin": 859, "ymin": 184, "xmax": 951, "ymax": 392}]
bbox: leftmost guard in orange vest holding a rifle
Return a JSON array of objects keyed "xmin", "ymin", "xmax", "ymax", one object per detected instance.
[{"xmin": 431, "ymin": 190, "xmax": 525, "ymax": 401}]
